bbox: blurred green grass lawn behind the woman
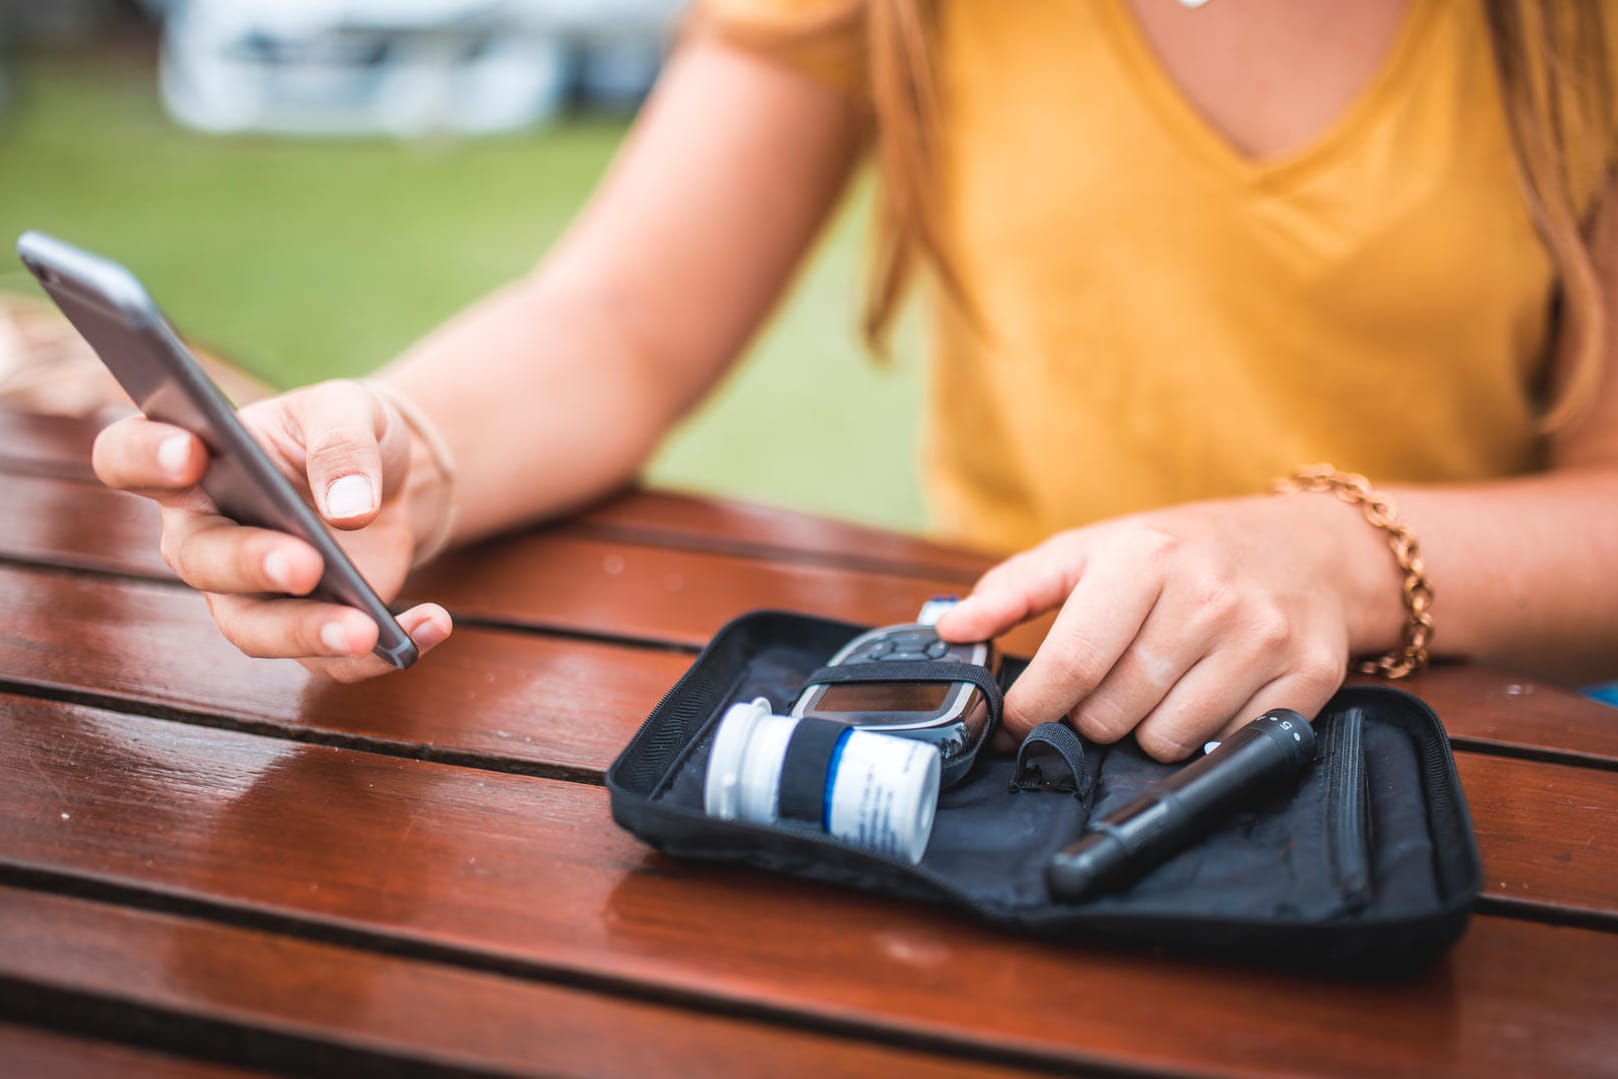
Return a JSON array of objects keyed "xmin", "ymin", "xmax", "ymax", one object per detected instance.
[{"xmin": 0, "ymin": 49, "xmax": 924, "ymax": 531}]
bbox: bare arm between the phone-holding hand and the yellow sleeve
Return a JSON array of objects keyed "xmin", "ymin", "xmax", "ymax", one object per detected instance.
[{"xmin": 380, "ymin": 37, "xmax": 862, "ymax": 550}]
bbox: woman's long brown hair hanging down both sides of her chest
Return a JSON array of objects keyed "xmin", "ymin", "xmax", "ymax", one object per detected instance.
[{"xmin": 715, "ymin": 0, "xmax": 1615, "ymax": 432}]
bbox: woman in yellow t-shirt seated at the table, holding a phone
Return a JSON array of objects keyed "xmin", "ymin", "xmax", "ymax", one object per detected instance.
[{"xmin": 95, "ymin": 0, "xmax": 1618, "ymax": 760}]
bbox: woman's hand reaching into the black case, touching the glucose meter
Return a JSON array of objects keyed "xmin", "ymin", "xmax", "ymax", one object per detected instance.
[{"xmin": 938, "ymin": 495, "xmax": 1401, "ymax": 760}]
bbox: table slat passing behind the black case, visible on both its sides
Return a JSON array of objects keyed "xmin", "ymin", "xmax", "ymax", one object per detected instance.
[{"xmin": 9, "ymin": 566, "xmax": 1618, "ymax": 912}]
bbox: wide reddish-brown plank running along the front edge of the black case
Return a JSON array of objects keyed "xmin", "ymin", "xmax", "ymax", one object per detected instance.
[{"xmin": 0, "ymin": 699, "xmax": 1618, "ymax": 1074}]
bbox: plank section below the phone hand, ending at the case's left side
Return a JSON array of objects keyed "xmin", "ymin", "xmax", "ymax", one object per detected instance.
[{"xmin": 0, "ymin": 566, "xmax": 691, "ymax": 776}]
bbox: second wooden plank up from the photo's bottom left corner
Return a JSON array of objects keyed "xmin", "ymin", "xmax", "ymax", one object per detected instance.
[{"xmin": 0, "ymin": 886, "xmax": 1029, "ymax": 1079}]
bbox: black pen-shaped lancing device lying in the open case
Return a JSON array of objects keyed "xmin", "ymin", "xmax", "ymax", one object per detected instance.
[{"xmin": 1045, "ymin": 709, "xmax": 1314, "ymax": 903}]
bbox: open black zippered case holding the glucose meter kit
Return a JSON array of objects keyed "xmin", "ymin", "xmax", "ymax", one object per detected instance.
[{"xmin": 607, "ymin": 611, "xmax": 1482, "ymax": 972}]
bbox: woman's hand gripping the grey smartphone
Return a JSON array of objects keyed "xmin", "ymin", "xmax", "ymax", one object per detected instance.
[{"xmin": 94, "ymin": 382, "xmax": 451, "ymax": 681}]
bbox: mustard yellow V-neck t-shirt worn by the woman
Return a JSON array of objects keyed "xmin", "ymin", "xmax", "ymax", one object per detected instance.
[{"xmin": 707, "ymin": 0, "xmax": 1555, "ymax": 550}]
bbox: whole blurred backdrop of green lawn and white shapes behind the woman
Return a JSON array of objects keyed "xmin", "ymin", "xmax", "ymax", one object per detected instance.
[{"xmin": 0, "ymin": 0, "xmax": 924, "ymax": 531}]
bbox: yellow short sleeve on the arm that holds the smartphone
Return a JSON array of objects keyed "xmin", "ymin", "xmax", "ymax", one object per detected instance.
[{"xmin": 686, "ymin": 0, "xmax": 869, "ymax": 102}]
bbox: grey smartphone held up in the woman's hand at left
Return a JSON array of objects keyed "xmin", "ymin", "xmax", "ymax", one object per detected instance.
[{"xmin": 16, "ymin": 231, "xmax": 417, "ymax": 668}]
